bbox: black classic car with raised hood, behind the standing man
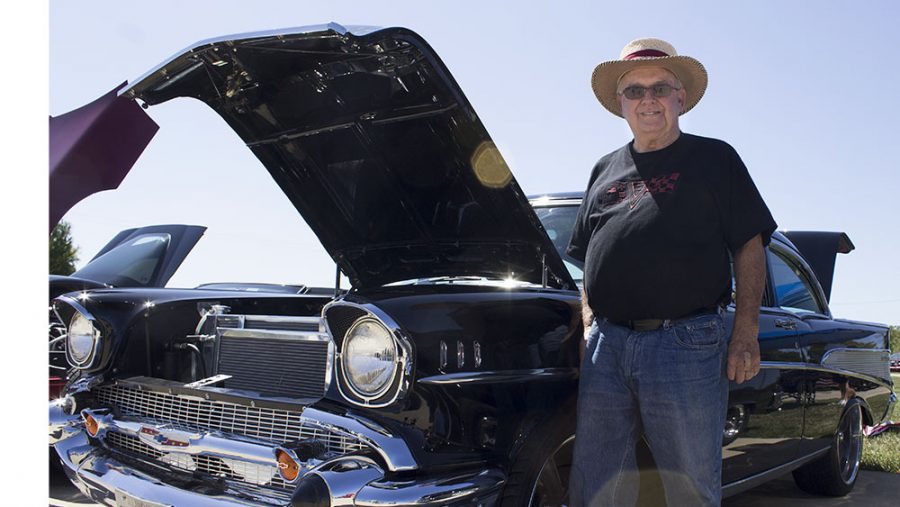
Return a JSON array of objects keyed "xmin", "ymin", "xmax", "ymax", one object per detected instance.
[{"xmin": 50, "ymin": 25, "xmax": 894, "ymax": 506}]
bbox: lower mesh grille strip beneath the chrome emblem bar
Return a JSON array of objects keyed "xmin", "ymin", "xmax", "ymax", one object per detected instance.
[{"xmin": 106, "ymin": 432, "xmax": 291, "ymax": 489}]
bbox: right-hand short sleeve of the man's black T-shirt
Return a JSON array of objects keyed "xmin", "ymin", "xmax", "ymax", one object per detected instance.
[{"xmin": 722, "ymin": 146, "xmax": 777, "ymax": 254}]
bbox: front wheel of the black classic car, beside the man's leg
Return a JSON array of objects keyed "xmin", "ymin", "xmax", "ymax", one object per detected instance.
[{"xmin": 500, "ymin": 412, "xmax": 575, "ymax": 507}]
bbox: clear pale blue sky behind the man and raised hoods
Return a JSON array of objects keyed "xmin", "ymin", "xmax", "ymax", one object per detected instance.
[{"xmin": 47, "ymin": 0, "xmax": 900, "ymax": 324}]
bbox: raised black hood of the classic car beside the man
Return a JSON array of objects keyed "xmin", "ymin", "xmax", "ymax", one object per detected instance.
[{"xmin": 121, "ymin": 24, "xmax": 575, "ymax": 289}]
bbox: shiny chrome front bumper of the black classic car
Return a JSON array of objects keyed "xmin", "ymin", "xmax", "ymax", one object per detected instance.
[{"xmin": 49, "ymin": 398, "xmax": 506, "ymax": 507}]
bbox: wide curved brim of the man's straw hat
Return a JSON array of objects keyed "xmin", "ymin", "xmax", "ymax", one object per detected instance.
[{"xmin": 591, "ymin": 56, "xmax": 709, "ymax": 118}]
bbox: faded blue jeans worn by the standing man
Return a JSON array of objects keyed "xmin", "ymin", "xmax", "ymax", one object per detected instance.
[{"xmin": 569, "ymin": 314, "xmax": 728, "ymax": 507}]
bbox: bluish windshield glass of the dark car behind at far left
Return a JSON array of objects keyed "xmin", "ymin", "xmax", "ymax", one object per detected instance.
[{"xmin": 72, "ymin": 233, "xmax": 171, "ymax": 287}]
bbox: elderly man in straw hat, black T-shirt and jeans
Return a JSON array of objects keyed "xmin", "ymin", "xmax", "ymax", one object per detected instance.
[{"xmin": 568, "ymin": 39, "xmax": 775, "ymax": 506}]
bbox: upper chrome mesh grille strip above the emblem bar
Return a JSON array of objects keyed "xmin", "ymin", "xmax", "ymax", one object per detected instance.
[{"xmin": 95, "ymin": 385, "xmax": 365, "ymax": 454}]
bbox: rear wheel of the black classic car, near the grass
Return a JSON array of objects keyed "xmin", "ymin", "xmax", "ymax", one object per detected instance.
[{"xmin": 794, "ymin": 403, "xmax": 863, "ymax": 496}]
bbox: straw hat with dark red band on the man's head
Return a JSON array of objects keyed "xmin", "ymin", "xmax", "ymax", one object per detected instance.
[{"xmin": 591, "ymin": 39, "xmax": 707, "ymax": 117}]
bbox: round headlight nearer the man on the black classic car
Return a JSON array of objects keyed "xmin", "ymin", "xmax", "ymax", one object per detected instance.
[{"xmin": 341, "ymin": 318, "xmax": 397, "ymax": 399}]
